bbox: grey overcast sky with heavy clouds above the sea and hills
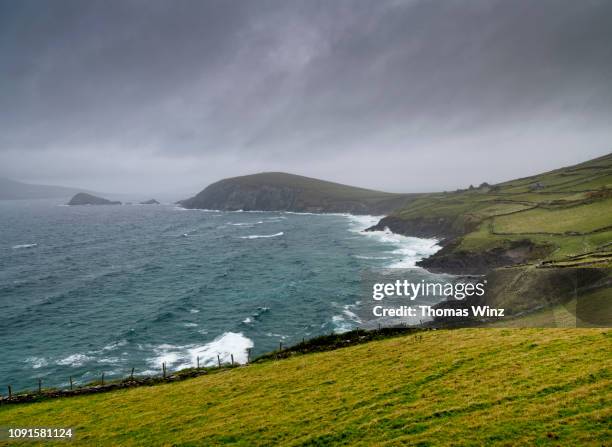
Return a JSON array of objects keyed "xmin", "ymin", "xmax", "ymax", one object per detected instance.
[{"xmin": 0, "ymin": 0, "xmax": 612, "ymax": 195}]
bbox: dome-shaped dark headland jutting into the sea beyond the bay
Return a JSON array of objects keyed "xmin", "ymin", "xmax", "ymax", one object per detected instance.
[{"xmin": 179, "ymin": 172, "xmax": 419, "ymax": 214}]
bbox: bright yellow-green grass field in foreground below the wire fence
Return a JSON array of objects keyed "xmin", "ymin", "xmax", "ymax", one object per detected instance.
[{"xmin": 0, "ymin": 329, "xmax": 612, "ymax": 446}]
